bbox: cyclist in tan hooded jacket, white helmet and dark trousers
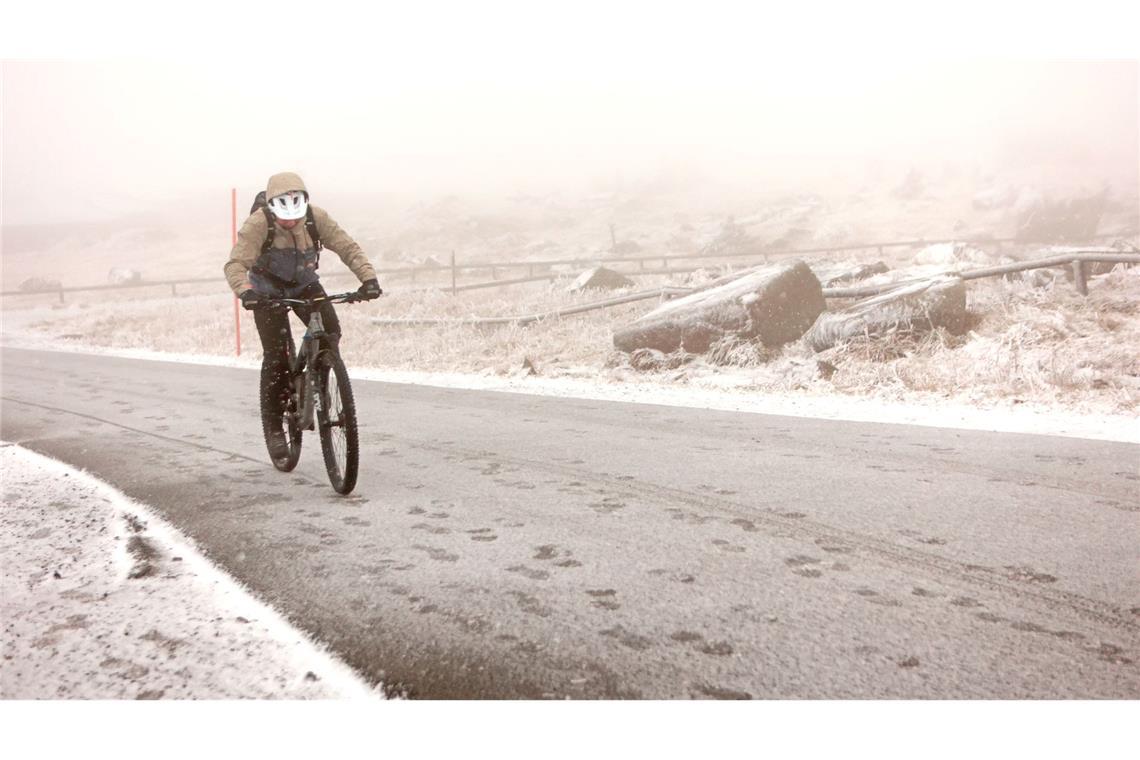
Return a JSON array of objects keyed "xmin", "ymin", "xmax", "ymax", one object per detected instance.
[{"xmin": 225, "ymin": 172, "xmax": 381, "ymax": 458}]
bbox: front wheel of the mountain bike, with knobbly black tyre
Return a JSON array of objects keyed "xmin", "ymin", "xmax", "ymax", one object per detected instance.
[{"xmin": 317, "ymin": 351, "xmax": 360, "ymax": 493}]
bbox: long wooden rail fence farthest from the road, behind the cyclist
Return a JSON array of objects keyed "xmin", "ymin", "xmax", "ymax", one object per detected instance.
[{"xmin": 0, "ymin": 230, "xmax": 1140, "ymax": 302}]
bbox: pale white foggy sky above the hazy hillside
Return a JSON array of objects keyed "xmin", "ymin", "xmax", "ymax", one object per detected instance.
[{"xmin": 2, "ymin": 56, "xmax": 1140, "ymax": 226}]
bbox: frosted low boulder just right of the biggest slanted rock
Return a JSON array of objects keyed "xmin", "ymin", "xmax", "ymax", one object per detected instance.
[{"xmin": 806, "ymin": 276, "xmax": 968, "ymax": 351}]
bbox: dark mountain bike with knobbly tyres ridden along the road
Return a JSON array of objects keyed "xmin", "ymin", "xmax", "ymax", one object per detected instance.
[{"xmin": 261, "ymin": 291, "xmax": 364, "ymax": 493}]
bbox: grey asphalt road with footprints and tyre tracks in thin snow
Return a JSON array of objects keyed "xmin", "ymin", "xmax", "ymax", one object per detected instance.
[{"xmin": 0, "ymin": 349, "xmax": 1140, "ymax": 698}]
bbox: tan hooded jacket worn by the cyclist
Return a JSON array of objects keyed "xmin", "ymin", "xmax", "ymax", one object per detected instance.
[{"xmin": 223, "ymin": 172, "xmax": 376, "ymax": 295}]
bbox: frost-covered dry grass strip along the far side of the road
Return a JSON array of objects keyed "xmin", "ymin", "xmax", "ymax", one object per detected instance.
[{"xmin": 5, "ymin": 255, "xmax": 1140, "ymax": 414}]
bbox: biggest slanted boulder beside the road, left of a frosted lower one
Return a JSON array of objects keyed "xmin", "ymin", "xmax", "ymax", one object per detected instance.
[{"xmin": 613, "ymin": 261, "xmax": 824, "ymax": 353}]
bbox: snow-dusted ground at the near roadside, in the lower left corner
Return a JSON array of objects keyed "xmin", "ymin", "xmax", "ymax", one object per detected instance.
[{"xmin": 0, "ymin": 443, "xmax": 381, "ymax": 700}]
